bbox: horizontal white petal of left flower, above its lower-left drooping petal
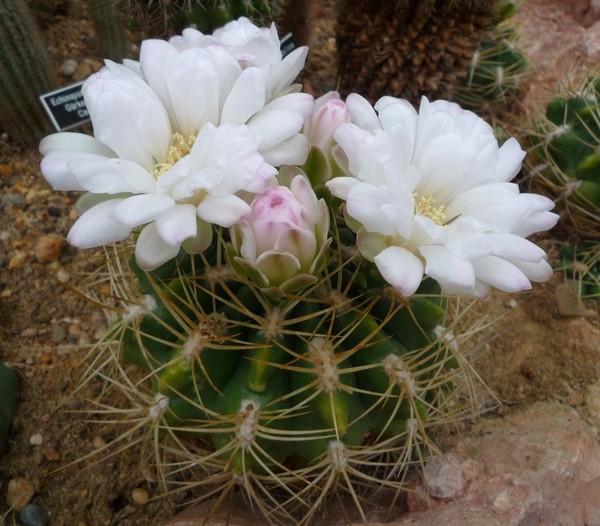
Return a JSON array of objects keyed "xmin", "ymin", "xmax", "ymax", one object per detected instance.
[{"xmin": 68, "ymin": 159, "xmax": 156, "ymax": 194}]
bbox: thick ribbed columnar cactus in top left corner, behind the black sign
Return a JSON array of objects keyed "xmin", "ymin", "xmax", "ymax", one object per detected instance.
[{"xmin": 0, "ymin": 0, "xmax": 56, "ymax": 145}]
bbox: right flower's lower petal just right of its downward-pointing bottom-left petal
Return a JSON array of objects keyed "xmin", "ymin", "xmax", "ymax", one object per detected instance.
[{"xmin": 419, "ymin": 245, "xmax": 475, "ymax": 288}]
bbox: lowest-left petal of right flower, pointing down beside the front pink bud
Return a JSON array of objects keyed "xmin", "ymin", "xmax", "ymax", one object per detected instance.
[{"xmin": 374, "ymin": 247, "xmax": 423, "ymax": 298}]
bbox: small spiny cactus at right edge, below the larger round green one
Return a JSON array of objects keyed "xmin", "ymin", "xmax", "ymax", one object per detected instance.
[{"xmin": 557, "ymin": 242, "xmax": 600, "ymax": 300}]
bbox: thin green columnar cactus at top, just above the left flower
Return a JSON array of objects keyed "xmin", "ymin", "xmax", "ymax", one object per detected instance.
[{"xmin": 87, "ymin": 0, "xmax": 127, "ymax": 60}]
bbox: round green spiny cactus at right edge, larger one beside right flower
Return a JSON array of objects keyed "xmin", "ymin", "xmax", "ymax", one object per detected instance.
[{"xmin": 528, "ymin": 76, "xmax": 600, "ymax": 239}]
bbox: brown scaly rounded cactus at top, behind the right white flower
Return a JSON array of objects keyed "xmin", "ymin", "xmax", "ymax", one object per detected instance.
[{"xmin": 337, "ymin": 0, "xmax": 497, "ymax": 102}]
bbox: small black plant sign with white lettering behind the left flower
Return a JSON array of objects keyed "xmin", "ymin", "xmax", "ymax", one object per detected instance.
[{"xmin": 40, "ymin": 82, "xmax": 90, "ymax": 131}]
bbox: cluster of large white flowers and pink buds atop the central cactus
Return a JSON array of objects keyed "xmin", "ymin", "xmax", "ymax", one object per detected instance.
[{"xmin": 40, "ymin": 19, "xmax": 557, "ymax": 297}]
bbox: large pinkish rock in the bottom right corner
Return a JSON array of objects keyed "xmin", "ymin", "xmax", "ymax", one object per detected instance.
[{"xmin": 398, "ymin": 403, "xmax": 600, "ymax": 526}]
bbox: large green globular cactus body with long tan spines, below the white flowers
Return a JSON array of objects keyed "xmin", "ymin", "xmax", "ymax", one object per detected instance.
[{"xmin": 84, "ymin": 213, "xmax": 490, "ymax": 524}]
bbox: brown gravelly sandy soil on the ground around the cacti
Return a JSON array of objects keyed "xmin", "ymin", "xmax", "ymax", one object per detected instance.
[{"xmin": 0, "ymin": 0, "xmax": 600, "ymax": 526}]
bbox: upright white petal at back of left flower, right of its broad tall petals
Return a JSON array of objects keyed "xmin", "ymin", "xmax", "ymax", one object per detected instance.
[{"xmin": 221, "ymin": 68, "xmax": 266, "ymax": 124}]
